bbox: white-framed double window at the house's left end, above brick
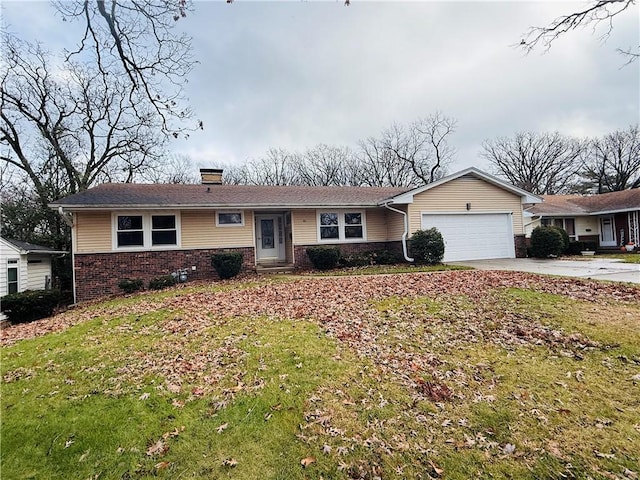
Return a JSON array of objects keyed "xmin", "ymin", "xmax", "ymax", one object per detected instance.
[{"xmin": 113, "ymin": 213, "xmax": 180, "ymax": 249}]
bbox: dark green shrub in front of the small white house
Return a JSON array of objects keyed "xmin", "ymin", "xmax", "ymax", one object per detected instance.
[{"xmin": 0, "ymin": 290, "xmax": 60, "ymax": 323}]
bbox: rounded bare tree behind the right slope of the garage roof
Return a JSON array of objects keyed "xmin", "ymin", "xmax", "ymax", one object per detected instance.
[{"xmin": 480, "ymin": 132, "xmax": 583, "ymax": 195}]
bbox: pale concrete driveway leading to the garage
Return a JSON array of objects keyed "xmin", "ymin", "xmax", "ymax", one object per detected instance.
[{"xmin": 447, "ymin": 257, "xmax": 640, "ymax": 283}]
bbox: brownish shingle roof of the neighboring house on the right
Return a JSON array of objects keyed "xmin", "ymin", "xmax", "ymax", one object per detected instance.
[{"xmin": 529, "ymin": 188, "xmax": 640, "ymax": 216}]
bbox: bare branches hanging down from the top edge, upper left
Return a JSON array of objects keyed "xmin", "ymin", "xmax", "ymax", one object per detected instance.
[{"xmin": 54, "ymin": 0, "xmax": 202, "ymax": 136}]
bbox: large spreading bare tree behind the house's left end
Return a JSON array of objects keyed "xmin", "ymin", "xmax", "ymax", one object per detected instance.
[{"xmin": 0, "ymin": 37, "xmax": 163, "ymax": 196}]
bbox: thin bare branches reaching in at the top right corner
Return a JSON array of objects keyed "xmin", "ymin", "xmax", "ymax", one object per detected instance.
[{"xmin": 520, "ymin": 0, "xmax": 640, "ymax": 63}]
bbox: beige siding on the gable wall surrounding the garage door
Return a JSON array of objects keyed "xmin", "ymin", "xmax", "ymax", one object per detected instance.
[{"xmin": 409, "ymin": 176, "xmax": 524, "ymax": 235}]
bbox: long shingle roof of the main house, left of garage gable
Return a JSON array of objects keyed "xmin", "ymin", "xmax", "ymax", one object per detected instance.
[{"xmin": 50, "ymin": 183, "xmax": 409, "ymax": 209}]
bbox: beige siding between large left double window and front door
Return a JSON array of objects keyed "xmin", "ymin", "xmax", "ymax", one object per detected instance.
[{"xmin": 180, "ymin": 210, "xmax": 254, "ymax": 248}]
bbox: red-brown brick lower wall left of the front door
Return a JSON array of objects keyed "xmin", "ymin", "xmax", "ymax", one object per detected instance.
[{"xmin": 75, "ymin": 247, "xmax": 255, "ymax": 302}]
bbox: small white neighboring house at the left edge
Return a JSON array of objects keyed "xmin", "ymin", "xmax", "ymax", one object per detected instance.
[{"xmin": 0, "ymin": 238, "xmax": 68, "ymax": 297}]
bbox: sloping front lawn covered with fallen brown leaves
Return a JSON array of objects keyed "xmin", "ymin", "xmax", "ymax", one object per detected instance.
[{"xmin": 0, "ymin": 271, "xmax": 640, "ymax": 479}]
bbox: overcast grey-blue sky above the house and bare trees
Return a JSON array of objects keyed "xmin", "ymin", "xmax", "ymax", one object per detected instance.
[{"xmin": 2, "ymin": 0, "xmax": 640, "ymax": 172}]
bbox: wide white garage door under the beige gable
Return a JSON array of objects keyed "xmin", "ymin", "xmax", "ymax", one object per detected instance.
[{"xmin": 422, "ymin": 213, "xmax": 516, "ymax": 262}]
